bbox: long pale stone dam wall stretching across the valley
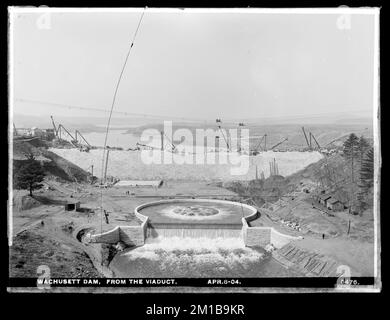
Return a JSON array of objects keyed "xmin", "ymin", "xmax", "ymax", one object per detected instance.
[{"xmin": 50, "ymin": 148, "xmax": 323, "ymax": 181}]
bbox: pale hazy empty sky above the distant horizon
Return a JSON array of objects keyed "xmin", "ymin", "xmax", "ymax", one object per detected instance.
[{"xmin": 11, "ymin": 10, "xmax": 374, "ymax": 119}]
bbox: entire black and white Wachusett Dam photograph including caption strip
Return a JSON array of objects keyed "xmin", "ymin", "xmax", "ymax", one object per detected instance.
[{"xmin": 8, "ymin": 6, "xmax": 382, "ymax": 294}]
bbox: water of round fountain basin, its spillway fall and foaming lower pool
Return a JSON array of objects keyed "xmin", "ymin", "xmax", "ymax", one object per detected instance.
[{"xmin": 110, "ymin": 199, "xmax": 304, "ymax": 278}]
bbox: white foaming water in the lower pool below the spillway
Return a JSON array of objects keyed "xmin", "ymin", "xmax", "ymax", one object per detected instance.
[{"xmin": 110, "ymin": 237, "xmax": 304, "ymax": 278}]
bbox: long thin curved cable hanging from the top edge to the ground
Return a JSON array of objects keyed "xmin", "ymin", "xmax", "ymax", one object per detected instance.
[{"xmin": 100, "ymin": 8, "xmax": 146, "ymax": 233}]
